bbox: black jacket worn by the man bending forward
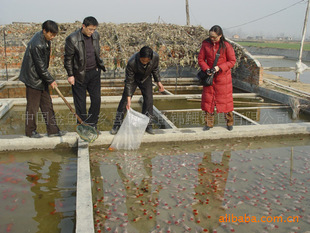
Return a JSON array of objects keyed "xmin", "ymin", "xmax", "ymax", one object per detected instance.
[{"xmin": 125, "ymin": 52, "xmax": 161, "ymax": 96}]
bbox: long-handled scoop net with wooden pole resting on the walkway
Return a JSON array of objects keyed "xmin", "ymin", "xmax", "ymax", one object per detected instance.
[{"xmin": 55, "ymin": 87, "xmax": 99, "ymax": 142}]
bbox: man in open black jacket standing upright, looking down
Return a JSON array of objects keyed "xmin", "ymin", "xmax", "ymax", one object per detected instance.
[{"xmin": 64, "ymin": 16, "xmax": 105, "ymax": 129}]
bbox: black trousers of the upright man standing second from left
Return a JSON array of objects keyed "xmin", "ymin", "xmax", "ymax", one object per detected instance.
[{"xmin": 72, "ymin": 69, "xmax": 101, "ymax": 127}]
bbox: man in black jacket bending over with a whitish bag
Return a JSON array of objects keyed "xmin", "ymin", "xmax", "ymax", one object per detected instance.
[{"xmin": 110, "ymin": 46, "xmax": 165, "ymax": 135}]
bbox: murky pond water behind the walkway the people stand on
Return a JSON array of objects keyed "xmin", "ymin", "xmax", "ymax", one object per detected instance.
[{"xmin": 0, "ymin": 95, "xmax": 310, "ymax": 135}]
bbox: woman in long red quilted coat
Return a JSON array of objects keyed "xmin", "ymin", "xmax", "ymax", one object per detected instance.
[{"xmin": 198, "ymin": 25, "xmax": 236, "ymax": 130}]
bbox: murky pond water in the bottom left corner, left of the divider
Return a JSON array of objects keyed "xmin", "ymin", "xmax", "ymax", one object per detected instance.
[{"xmin": 0, "ymin": 149, "xmax": 77, "ymax": 233}]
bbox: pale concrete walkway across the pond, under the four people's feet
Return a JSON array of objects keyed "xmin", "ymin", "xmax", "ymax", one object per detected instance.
[{"xmin": 0, "ymin": 122, "xmax": 310, "ymax": 151}]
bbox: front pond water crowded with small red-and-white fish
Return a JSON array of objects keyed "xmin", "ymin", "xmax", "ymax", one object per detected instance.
[{"xmin": 90, "ymin": 136, "xmax": 310, "ymax": 233}]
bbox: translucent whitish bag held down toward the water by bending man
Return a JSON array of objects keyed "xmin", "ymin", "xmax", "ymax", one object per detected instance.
[{"xmin": 110, "ymin": 108, "xmax": 150, "ymax": 150}]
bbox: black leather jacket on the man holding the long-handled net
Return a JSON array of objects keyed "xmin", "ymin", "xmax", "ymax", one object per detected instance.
[{"xmin": 19, "ymin": 31, "xmax": 55, "ymax": 90}]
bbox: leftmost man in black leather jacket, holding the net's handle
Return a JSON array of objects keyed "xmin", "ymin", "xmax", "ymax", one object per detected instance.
[{"xmin": 19, "ymin": 20, "xmax": 65, "ymax": 138}]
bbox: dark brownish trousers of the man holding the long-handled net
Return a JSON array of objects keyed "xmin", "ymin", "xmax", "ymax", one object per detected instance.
[{"xmin": 25, "ymin": 87, "xmax": 59, "ymax": 137}]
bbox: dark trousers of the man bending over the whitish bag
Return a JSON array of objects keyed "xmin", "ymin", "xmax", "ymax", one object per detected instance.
[{"xmin": 114, "ymin": 77, "xmax": 153, "ymax": 126}]
